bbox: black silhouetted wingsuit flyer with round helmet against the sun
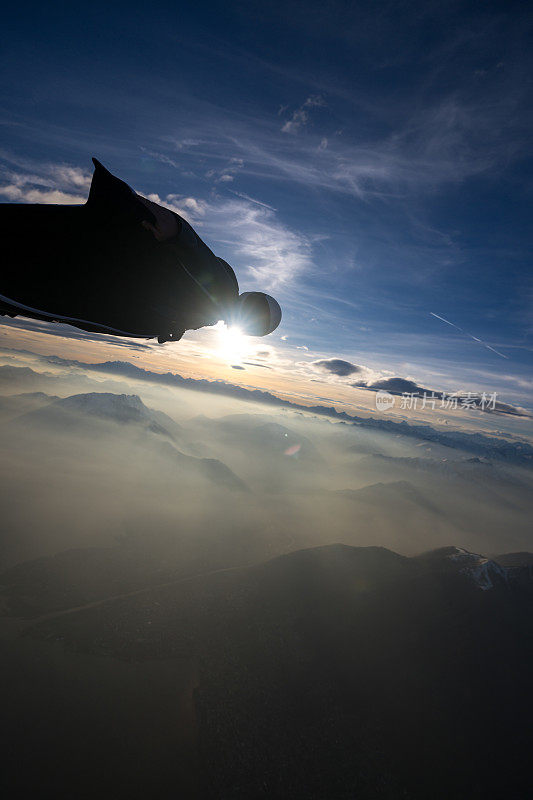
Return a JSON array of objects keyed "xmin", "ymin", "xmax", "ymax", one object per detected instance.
[{"xmin": 0, "ymin": 158, "xmax": 281, "ymax": 343}]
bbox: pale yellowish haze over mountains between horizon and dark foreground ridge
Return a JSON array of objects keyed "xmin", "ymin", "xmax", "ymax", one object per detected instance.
[{"xmin": 0, "ymin": 354, "xmax": 533, "ymax": 572}]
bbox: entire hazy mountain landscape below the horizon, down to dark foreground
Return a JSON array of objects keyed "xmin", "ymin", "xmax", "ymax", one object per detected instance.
[{"xmin": 0, "ymin": 367, "xmax": 533, "ymax": 799}]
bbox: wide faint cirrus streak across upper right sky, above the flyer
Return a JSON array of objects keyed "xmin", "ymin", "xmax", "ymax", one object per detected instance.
[{"xmin": 155, "ymin": 83, "xmax": 528, "ymax": 202}]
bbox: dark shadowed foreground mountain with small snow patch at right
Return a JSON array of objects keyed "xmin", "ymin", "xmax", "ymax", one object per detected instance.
[{"xmin": 6, "ymin": 545, "xmax": 533, "ymax": 800}]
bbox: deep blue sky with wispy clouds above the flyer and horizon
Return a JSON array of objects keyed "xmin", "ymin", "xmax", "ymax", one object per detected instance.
[{"xmin": 0, "ymin": 2, "xmax": 533, "ymax": 406}]
